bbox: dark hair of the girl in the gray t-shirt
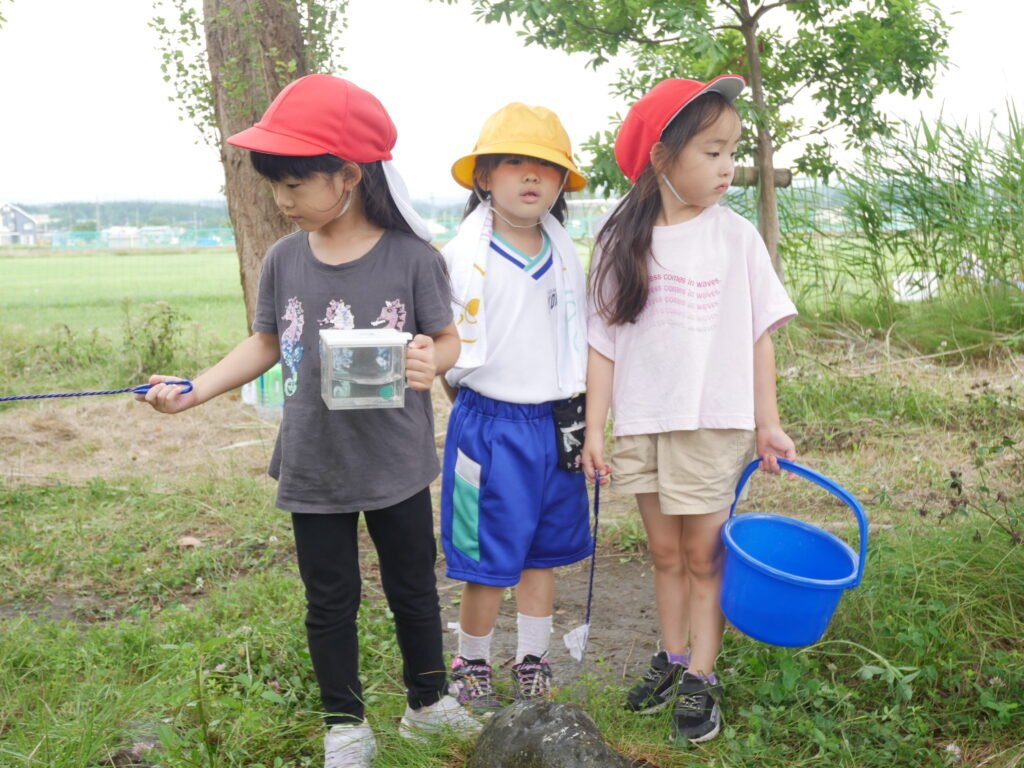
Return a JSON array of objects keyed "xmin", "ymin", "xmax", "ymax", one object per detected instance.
[{"xmin": 249, "ymin": 152, "xmax": 418, "ymax": 238}]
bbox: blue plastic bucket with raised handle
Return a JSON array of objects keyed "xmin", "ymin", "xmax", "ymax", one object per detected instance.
[{"xmin": 722, "ymin": 459, "xmax": 867, "ymax": 647}]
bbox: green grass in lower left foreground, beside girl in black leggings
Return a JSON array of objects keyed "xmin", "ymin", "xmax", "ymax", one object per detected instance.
[{"xmin": 0, "ymin": 481, "xmax": 471, "ymax": 766}]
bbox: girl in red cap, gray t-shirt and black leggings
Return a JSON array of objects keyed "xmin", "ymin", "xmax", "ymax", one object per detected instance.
[{"xmin": 137, "ymin": 75, "xmax": 479, "ymax": 768}]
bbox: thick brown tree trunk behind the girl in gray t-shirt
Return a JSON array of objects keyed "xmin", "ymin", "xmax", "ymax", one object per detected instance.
[{"xmin": 203, "ymin": 0, "xmax": 306, "ymax": 330}]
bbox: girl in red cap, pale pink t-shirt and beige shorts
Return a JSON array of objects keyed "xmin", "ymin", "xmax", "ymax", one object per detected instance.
[{"xmin": 583, "ymin": 75, "xmax": 797, "ymax": 741}]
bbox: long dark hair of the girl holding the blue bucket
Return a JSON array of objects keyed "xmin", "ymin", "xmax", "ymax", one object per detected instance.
[{"xmin": 590, "ymin": 92, "xmax": 736, "ymax": 326}]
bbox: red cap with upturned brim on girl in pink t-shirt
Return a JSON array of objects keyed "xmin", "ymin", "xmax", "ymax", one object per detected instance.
[{"xmin": 615, "ymin": 75, "xmax": 746, "ymax": 183}]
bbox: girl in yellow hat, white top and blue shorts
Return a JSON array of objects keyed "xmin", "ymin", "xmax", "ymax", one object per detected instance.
[{"xmin": 441, "ymin": 103, "xmax": 593, "ymax": 713}]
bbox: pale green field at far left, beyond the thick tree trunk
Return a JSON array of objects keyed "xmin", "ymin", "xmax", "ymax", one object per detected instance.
[{"xmin": 0, "ymin": 250, "xmax": 246, "ymax": 399}]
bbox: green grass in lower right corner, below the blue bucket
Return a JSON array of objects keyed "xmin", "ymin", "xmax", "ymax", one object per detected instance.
[{"xmin": 590, "ymin": 525, "xmax": 1024, "ymax": 766}]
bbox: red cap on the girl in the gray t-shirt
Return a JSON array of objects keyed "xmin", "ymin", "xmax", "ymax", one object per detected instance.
[{"xmin": 227, "ymin": 75, "xmax": 398, "ymax": 163}]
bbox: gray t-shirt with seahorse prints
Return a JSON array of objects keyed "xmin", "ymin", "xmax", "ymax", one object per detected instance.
[{"xmin": 253, "ymin": 230, "xmax": 452, "ymax": 513}]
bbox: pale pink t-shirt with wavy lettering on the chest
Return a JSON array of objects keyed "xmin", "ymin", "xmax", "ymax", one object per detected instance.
[{"xmin": 588, "ymin": 201, "xmax": 797, "ymax": 436}]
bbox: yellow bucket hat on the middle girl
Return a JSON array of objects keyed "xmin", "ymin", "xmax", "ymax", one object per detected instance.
[{"xmin": 452, "ymin": 101, "xmax": 587, "ymax": 191}]
